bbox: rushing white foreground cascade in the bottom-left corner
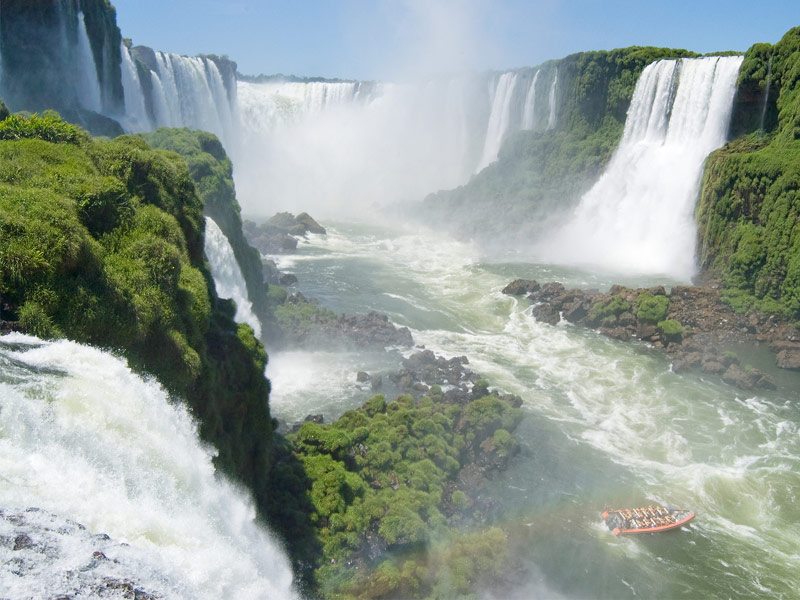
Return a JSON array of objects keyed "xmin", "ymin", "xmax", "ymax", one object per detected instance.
[{"xmin": 0, "ymin": 334, "xmax": 295, "ymax": 600}]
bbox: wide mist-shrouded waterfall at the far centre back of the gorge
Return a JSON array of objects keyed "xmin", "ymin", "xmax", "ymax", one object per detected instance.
[{"xmin": 230, "ymin": 75, "xmax": 490, "ymax": 219}]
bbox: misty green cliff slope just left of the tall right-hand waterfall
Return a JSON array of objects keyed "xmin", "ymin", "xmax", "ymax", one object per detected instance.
[{"xmin": 424, "ymin": 47, "xmax": 696, "ymax": 244}]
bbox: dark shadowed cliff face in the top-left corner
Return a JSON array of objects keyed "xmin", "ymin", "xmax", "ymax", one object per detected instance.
[{"xmin": 0, "ymin": 0, "xmax": 124, "ymax": 114}]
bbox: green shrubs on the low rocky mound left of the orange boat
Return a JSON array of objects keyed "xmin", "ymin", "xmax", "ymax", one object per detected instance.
[{"xmin": 289, "ymin": 387, "xmax": 521, "ymax": 598}]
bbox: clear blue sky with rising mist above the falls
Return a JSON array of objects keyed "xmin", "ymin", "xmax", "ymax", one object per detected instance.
[{"xmin": 112, "ymin": 0, "xmax": 800, "ymax": 80}]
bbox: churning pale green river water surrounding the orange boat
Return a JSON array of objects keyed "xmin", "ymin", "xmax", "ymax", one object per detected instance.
[{"xmin": 268, "ymin": 223, "xmax": 800, "ymax": 598}]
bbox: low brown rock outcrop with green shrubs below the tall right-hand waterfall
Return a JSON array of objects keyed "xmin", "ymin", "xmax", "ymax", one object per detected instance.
[{"xmin": 503, "ymin": 280, "xmax": 800, "ymax": 390}]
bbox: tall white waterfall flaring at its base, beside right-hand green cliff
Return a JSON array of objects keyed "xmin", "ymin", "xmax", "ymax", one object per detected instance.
[{"xmin": 537, "ymin": 56, "xmax": 742, "ymax": 281}]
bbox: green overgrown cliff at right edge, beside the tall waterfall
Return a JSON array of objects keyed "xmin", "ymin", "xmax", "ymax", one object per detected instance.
[{"xmin": 696, "ymin": 28, "xmax": 800, "ymax": 319}]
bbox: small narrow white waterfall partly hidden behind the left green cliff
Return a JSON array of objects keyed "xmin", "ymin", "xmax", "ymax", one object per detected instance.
[{"xmin": 205, "ymin": 217, "xmax": 261, "ymax": 338}]
